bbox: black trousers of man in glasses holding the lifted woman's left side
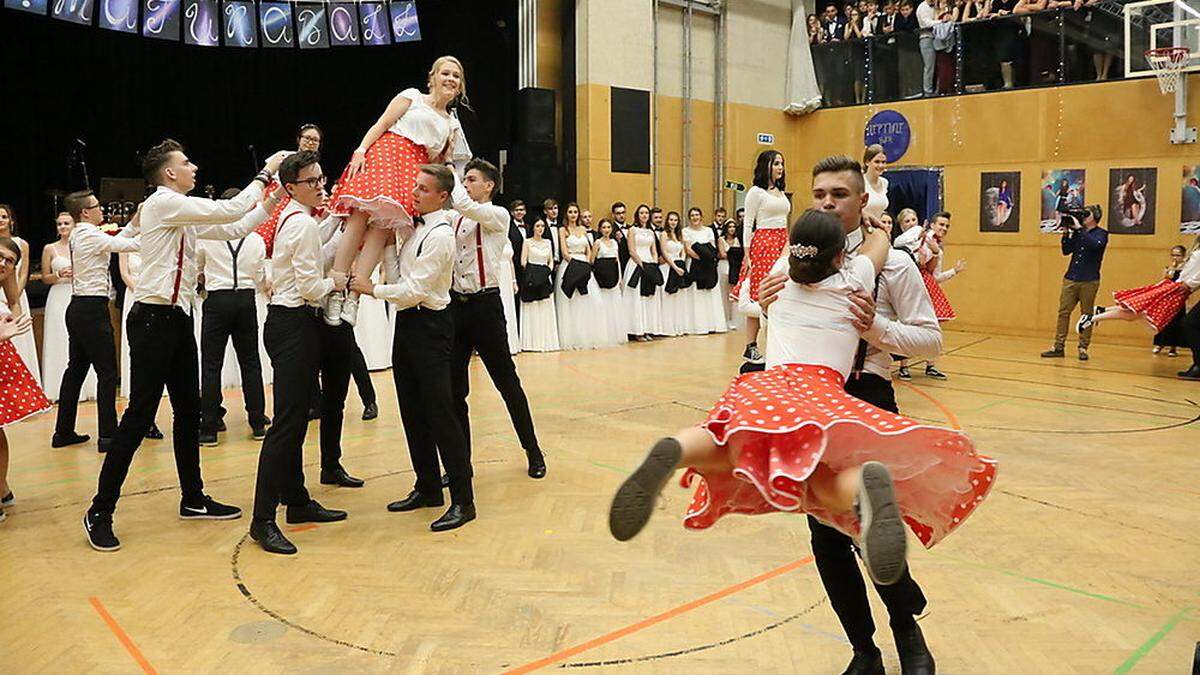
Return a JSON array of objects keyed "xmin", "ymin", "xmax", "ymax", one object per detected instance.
[{"xmin": 254, "ymin": 305, "xmax": 320, "ymax": 520}]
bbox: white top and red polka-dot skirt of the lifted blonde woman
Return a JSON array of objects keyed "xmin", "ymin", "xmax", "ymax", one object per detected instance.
[{"xmin": 330, "ymin": 89, "xmax": 458, "ymax": 229}]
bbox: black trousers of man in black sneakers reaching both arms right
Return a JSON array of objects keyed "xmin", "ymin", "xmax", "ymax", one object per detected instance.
[{"xmin": 91, "ymin": 303, "xmax": 204, "ymax": 514}]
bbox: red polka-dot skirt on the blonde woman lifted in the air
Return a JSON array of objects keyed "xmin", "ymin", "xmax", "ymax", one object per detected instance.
[{"xmin": 329, "ymin": 131, "xmax": 430, "ymax": 229}]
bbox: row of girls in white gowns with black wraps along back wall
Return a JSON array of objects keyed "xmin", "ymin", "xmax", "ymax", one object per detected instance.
[{"xmin": 518, "ymin": 203, "xmax": 740, "ymax": 352}]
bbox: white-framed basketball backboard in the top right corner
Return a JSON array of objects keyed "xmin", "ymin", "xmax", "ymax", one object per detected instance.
[{"xmin": 1122, "ymin": 0, "xmax": 1200, "ymax": 77}]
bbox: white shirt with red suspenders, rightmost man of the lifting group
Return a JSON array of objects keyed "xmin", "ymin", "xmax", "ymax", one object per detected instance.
[{"xmin": 450, "ymin": 174, "xmax": 512, "ymax": 293}]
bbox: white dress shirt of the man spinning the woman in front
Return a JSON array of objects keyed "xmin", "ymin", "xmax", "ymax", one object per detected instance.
[{"xmin": 844, "ymin": 229, "xmax": 942, "ymax": 380}]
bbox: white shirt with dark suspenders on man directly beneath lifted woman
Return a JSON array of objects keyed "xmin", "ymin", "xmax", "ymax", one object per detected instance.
[{"xmin": 374, "ymin": 211, "xmax": 455, "ymax": 310}]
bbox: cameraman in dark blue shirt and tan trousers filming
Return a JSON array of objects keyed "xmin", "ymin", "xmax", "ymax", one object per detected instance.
[{"xmin": 1042, "ymin": 204, "xmax": 1109, "ymax": 362}]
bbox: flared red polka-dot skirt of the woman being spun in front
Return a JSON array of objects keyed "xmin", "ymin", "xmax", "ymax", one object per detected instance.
[{"xmin": 682, "ymin": 365, "xmax": 997, "ymax": 548}]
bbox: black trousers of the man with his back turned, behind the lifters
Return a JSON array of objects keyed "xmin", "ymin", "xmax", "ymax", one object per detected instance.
[{"xmin": 200, "ymin": 288, "xmax": 268, "ymax": 431}]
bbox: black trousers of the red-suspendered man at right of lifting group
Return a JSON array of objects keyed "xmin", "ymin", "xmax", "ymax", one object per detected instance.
[{"xmin": 450, "ymin": 285, "xmax": 539, "ymax": 452}]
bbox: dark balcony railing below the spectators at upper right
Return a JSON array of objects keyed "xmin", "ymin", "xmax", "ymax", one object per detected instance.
[{"xmin": 811, "ymin": 7, "xmax": 1132, "ymax": 107}]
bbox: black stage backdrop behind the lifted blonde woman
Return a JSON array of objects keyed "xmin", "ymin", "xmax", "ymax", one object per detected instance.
[{"xmin": 0, "ymin": 0, "xmax": 517, "ymax": 253}]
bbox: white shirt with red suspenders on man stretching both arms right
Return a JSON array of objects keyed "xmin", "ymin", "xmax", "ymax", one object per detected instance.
[{"xmin": 133, "ymin": 180, "xmax": 268, "ymax": 313}]
